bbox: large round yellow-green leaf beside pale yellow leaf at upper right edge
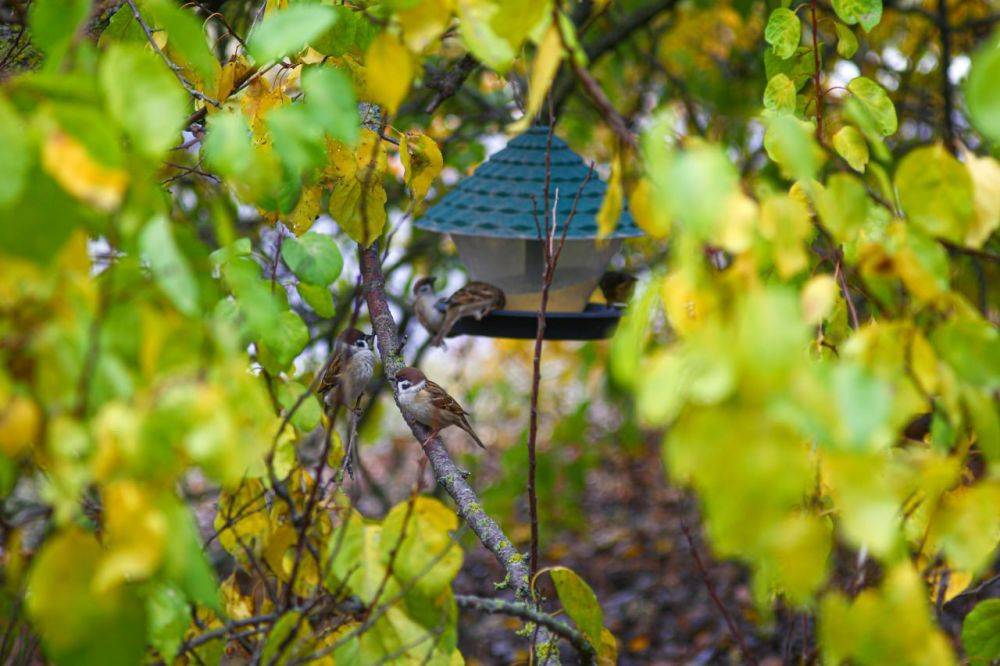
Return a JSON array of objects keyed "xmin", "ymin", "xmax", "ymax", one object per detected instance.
[{"xmin": 893, "ymin": 145, "xmax": 975, "ymax": 243}]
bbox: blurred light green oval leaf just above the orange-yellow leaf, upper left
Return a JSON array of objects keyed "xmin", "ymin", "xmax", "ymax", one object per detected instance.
[{"xmin": 99, "ymin": 44, "xmax": 189, "ymax": 158}]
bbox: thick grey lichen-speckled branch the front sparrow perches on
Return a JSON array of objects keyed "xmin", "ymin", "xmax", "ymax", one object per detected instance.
[{"xmin": 361, "ymin": 243, "xmax": 558, "ymax": 664}]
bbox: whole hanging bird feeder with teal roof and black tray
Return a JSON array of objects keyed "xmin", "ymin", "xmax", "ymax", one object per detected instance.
[{"xmin": 416, "ymin": 125, "xmax": 642, "ymax": 340}]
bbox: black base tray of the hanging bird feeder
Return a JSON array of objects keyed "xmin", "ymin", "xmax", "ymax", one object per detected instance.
[{"xmin": 448, "ymin": 303, "xmax": 622, "ymax": 340}]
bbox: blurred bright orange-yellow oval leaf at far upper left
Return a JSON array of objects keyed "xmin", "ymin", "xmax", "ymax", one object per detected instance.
[{"xmin": 42, "ymin": 130, "xmax": 128, "ymax": 212}]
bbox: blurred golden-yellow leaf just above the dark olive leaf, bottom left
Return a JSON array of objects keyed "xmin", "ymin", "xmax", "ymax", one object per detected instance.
[{"xmin": 94, "ymin": 481, "xmax": 169, "ymax": 592}]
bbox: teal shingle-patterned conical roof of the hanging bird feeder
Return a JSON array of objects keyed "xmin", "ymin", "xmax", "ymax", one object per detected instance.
[{"xmin": 416, "ymin": 125, "xmax": 642, "ymax": 240}]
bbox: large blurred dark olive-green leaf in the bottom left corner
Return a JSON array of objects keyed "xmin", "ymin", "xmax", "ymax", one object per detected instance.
[{"xmin": 25, "ymin": 527, "xmax": 146, "ymax": 666}]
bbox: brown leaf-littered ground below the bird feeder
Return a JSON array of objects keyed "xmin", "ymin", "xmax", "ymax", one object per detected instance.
[{"xmin": 358, "ymin": 436, "xmax": 800, "ymax": 666}]
